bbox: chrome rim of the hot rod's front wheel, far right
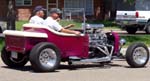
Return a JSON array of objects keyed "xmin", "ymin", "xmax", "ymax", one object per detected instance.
[{"xmin": 133, "ymin": 47, "xmax": 148, "ymax": 64}]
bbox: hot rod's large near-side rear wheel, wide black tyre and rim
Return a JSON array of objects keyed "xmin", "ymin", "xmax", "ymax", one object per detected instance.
[{"xmin": 29, "ymin": 42, "xmax": 61, "ymax": 72}]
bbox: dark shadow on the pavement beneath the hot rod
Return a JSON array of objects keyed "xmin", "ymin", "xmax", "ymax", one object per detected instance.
[{"xmin": 1, "ymin": 63, "xmax": 130, "ymax": 73}]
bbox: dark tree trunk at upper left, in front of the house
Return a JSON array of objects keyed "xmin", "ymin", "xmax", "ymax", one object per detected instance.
[{"xmin": 7, "ymin": 0, "xmax": 16, "ymax": 30}]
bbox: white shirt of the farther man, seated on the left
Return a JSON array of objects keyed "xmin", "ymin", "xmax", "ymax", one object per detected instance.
[{"xmin": 29, "ymin": 16, "xmax": 44, "ymax": 25}]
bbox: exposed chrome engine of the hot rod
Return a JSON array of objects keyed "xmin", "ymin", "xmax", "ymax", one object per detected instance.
[{"xmin": 87, "ymin": 28, "xmax": 114, "ymax": 58}]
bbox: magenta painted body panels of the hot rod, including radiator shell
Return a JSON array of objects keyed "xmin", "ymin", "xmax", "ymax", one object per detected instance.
[{"xmin": 5, "ymin": 26, "xmax": 120, "ymax": 58}]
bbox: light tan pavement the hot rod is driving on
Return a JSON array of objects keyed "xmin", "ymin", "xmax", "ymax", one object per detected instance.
[{"xmin": 0, "ymin": 56, "xmax": 150, "ymax": 81}]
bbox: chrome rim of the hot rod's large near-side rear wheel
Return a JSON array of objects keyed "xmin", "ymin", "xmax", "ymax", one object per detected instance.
[{"xmin": 39, "ymin": 48, "xmax": 57, "ymax": 68}]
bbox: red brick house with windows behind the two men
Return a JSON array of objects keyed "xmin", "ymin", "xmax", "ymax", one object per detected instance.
[{"xmin": 0, "ymin": 0, "xmax": 104, "ymax": 20}]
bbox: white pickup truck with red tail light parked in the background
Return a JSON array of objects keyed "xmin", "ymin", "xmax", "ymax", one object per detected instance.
[{"xmin": 116, "ymin": 0, "xmax": 150, "ymax": 34}]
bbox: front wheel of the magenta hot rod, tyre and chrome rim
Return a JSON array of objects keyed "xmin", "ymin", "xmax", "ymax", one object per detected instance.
[{"xmin": 126, "ymin": 43, "xmax": 149, "ymax": 68}]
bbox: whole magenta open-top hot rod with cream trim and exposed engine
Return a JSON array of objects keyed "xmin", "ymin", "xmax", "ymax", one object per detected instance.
[{"xmin": 1, "ymin": 24, "xmax": 149, "ymax": 72}]
